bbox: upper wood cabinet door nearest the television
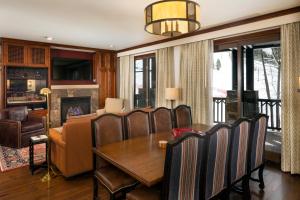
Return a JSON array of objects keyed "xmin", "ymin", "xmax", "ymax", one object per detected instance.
[{"xmin": 28, "ymin": 45, "xmax": 50, "ymax": 67}]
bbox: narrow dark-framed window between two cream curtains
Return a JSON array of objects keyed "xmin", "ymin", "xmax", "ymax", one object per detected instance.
[{"xmin": 134, "ymin": 54, "xmax": 156, "ymax": 108}]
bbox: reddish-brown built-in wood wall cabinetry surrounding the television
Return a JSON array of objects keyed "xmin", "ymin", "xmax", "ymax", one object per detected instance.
[{"xmin": 0, "ymin": 38, "xmax": 117, "ymax": 110}]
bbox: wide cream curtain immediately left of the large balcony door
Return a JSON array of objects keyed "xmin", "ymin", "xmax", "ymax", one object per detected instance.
[{"xmin": 179, "ymin": 40, "xmax": 213, "ymax": 124}]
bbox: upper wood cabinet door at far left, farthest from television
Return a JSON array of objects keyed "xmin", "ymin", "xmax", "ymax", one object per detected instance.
[{"xmin": 3, "ymin": 42, "xmax": 27, "ymax": 66}]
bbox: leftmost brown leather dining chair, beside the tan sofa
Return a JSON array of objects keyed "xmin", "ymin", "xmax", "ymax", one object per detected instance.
[{"xmin": 92, "ymin": 114, "xmax": 137, "ymax": 200}]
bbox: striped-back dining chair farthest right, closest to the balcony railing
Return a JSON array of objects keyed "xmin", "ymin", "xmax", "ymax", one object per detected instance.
[{"xmin": 248, "ymin": 114, "xmax": 269, "ymax": 189}]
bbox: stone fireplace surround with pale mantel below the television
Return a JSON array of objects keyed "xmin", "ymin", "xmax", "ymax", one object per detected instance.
[{"xmin": 50, "ymin": 84, "xmax": 99, "ymax": 127}]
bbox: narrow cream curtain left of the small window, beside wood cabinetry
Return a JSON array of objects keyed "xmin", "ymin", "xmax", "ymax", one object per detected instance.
[{"xmin": 119, "ymin": 56, "xmax": 134, "ymax": 111}]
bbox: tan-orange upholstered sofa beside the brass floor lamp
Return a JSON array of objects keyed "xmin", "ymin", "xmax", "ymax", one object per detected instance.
[{"xmin": 50, "ymin": 114, "xmax": 97, "ymax": 177}]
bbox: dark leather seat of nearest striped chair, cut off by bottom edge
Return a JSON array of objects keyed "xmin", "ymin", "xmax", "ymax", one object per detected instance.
[{"xmin": 126, "ymin": 186, "xmax": 160, "ymax": 200}]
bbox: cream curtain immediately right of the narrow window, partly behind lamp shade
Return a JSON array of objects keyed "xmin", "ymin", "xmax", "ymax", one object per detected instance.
[{"xmin": 156, "ymin": 47, "xmax": 175, "ymax": 107}]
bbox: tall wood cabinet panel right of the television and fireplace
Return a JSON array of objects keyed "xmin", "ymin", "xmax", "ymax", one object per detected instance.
[{"xmin": 94, "ymin": 52, "xmax": 116, "ymax": 108}]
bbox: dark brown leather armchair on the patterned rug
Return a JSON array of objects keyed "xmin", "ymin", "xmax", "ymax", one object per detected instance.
[{"xmin": 0, "ymin": 106, "xmax": 46, "ymax": 148}]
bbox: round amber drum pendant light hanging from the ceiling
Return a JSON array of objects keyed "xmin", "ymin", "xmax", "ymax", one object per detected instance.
[{"xmin": 145, "ymin": 0, "xmax": 200, "ymax": 37}]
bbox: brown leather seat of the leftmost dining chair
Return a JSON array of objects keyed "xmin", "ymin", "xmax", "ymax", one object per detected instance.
[{"xmin": 95, "ymin": 165, "xmax": 137, "ymax": 193}]
